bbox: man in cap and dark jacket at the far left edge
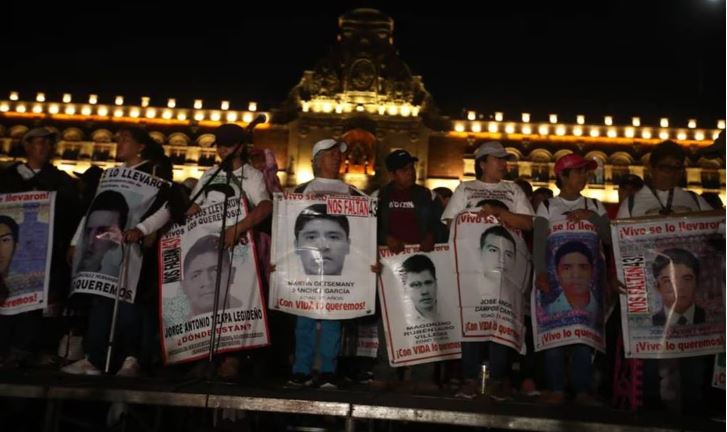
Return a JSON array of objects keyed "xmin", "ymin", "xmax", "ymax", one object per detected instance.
[{"xmin": 0, "ymin": 127, "xmax": 80, "ymax": 367}]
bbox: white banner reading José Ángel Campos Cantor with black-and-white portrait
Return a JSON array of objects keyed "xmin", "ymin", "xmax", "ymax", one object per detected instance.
[{"xmin": 450, "ymin": 211, "xmax": 531, "ymax": 353}]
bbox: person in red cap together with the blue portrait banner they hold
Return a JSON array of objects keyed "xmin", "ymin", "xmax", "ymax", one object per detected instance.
[{"xmin": 533, "ymin": 153, "xmax": 611, "ymax": 404}]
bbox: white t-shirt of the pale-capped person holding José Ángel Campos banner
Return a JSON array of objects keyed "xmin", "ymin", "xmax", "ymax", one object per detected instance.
[{"xmin": 442, "ymin": 180, "xmax": 533, "ymax": 221}]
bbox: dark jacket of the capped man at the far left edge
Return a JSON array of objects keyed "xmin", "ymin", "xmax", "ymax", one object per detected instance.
[{"xmin": 0, "ymin": 162, "xmax": 81, "ymax": 302}]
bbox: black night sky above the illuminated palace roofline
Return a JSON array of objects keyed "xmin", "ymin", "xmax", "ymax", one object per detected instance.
[{"xmin": 0, "ymin": 0, "xmax": 726, "ymax": 127}]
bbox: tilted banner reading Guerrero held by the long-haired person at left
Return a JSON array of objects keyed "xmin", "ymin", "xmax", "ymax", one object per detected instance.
[{"xmin": 71, "ymin": 167, "xmax": 169, "ymax": 303}]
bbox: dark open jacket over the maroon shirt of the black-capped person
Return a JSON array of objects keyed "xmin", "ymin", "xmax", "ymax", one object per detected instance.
[{"xmin": 376, "ymin": 183, "xmax": 440, "ymax": 245}]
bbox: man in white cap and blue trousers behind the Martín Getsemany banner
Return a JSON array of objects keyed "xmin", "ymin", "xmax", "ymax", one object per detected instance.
[{"xmin": 287, "ymin": 138, "xmax": 373, "ymax": 389}]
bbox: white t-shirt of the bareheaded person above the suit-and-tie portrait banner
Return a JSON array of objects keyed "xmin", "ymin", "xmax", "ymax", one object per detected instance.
[{"xmin": 617, "ymin": 186, "xmax": 712, "ymax": 219}]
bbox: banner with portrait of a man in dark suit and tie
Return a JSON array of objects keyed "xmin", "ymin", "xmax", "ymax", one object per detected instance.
[{"xmin": 611, "ymin": 213, "xmax": 725, "ymax": 358}]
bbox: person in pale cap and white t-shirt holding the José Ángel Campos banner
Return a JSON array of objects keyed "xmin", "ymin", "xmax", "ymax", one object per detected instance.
[{"xmin": 442, "ymin": 141, "xmax": 533, "ymax": 400}]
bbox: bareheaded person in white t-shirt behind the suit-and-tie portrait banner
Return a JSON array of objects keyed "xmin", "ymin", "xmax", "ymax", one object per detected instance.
[{"xmin": 618, "ymin": 141, "xmax": 713, "ymax": 414}]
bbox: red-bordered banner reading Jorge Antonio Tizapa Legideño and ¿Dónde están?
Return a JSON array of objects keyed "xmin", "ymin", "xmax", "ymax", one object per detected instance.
[{"xmin": 159, "ymin": 197, "xmax": 270, "ymax": 364}]
